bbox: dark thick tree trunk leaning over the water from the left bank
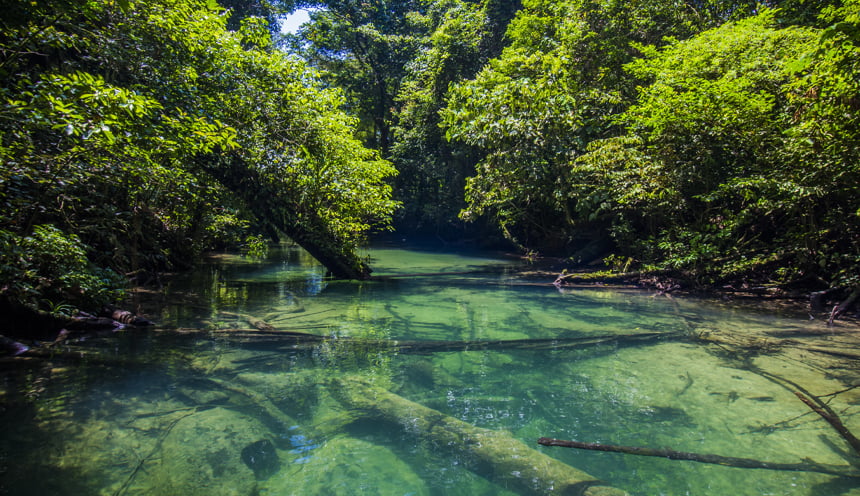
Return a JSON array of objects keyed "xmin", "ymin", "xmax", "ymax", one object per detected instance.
[{"xmin": 204, "ymin": 156, "xmax": 370, "ymax": 279}]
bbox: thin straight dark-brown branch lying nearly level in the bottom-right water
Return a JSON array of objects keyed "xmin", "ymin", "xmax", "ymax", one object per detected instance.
[{"xmin": 538, "ymin": 437, "xmax": 860, "ymax": 477}]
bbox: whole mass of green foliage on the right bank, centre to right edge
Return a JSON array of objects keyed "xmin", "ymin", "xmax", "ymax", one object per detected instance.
[{"xmin": 434, "ymin": 0, "xmax": 860, "ymax": 285}]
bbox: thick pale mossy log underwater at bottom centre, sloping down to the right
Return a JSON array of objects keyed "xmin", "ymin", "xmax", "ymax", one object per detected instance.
[{"xmin": 330, "ymin": 378, "xmax": 627, "ymax": 496}]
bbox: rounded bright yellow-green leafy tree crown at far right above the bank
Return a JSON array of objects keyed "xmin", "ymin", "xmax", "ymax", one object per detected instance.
[{"xmin": 574, "ymin": 6, "xmax": 860, "ymax": 285}]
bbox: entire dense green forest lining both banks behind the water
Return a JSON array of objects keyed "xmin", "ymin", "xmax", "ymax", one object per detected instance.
[{"xmin": 0, "ymin": 0, "xmax": 860, "ymax": 322}]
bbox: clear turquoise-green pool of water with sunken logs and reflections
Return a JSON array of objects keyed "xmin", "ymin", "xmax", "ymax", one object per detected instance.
[{"xmin": 0, "ymin": 247, "xmax": 860, "ymax": 496}]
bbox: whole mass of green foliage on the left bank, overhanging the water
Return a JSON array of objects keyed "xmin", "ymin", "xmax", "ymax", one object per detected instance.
[{"xmin": 0, "ymin": 0, "xmax": 396, "ymax": 314}]
